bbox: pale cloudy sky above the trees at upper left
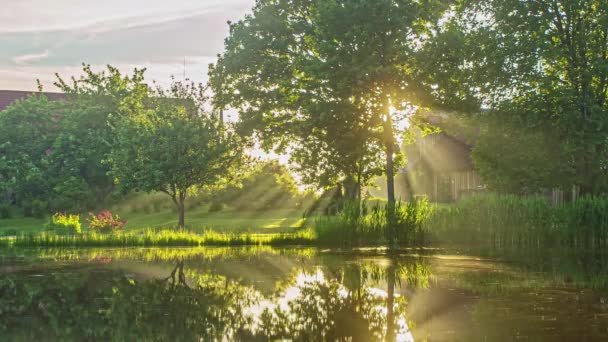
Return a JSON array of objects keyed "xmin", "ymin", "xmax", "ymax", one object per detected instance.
[{"xmin": 0, "ymin": 0, "xmax": 255, "ymax": 91}]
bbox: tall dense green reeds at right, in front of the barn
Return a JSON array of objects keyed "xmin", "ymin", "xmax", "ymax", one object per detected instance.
[{"xmin": 423, "ymin": 193, "xmax": 608, "ymax": 248}]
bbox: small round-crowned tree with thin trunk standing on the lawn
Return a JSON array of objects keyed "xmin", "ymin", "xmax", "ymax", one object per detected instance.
[{"xmin": 109, "ymin": 82, "xmax": 242, "ymax": 227}]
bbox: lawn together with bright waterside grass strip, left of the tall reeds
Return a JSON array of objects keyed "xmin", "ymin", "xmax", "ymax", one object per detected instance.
[{"xmin": 0, "ymin": 194, "xmax": 315, "ymax": 247}]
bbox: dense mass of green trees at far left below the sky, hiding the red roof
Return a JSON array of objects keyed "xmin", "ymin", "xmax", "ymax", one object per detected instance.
[{"xmin": 0, "ymin": 65, "xmax": 148, "ymax": 212}]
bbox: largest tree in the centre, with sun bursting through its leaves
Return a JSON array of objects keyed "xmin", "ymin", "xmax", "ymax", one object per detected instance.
[{"xmin": 211, "ymin": 0, "xmax": 443, "ymax": 208}]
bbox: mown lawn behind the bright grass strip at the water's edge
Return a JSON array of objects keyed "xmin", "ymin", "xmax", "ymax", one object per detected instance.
[{"xmin": 0, "ymin": 206, "xmax": 304, "ymax": 236}]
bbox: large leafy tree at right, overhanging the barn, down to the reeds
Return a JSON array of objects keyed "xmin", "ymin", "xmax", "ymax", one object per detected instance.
[{"xmin": 429, "ymin": 0, "xmax": 608, "ymax": 193}]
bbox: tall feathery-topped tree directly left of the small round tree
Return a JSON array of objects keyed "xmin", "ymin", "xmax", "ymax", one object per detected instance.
[{"xmin": 49, "ymin": 64, "xmax": 149, "ymax": 210}]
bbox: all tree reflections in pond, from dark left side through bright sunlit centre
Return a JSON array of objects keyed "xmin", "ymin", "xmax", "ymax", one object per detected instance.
[{"xmin": 0, "ymin": 252, "xmax": 430, "ymax": 341}]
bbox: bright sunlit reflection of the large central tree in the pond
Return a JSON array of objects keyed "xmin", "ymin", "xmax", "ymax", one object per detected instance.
[{"xmin": 252, "ymin": 260, "xmax": 430, "ymax": 341}]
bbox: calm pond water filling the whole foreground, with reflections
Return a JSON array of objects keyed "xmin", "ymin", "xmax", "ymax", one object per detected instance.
[{"xmin": 0, "ymin": 247, "xmax": 608, "ymax": 341}]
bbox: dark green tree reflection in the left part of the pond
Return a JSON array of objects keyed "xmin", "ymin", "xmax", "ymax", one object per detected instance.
[{"xmin": 0, "ymin": 261, "xmax": 255, "ymax": 341}]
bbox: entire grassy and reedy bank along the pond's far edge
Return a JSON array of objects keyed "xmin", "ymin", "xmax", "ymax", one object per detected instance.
[{"xmin": 0, "ymin": 194, "xmax": 608, "ymax": 249}]
